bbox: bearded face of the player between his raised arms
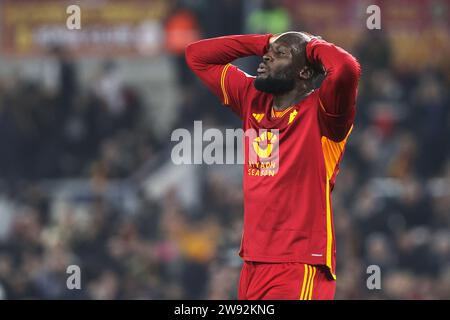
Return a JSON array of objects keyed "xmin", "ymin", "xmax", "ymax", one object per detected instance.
[{"xmin": 254, "ymin": 33, "xmax": 305, "ymax": 94}]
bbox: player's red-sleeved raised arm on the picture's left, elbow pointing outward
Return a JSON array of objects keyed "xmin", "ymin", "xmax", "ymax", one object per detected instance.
[{"xmin": 186, "ymin": 35, "xmax": 271, "ymax": 118}]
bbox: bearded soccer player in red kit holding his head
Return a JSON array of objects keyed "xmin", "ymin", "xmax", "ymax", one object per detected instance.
[{"xmin": 186, "ymin": 32, "xmax": 360, "ymax": 300}]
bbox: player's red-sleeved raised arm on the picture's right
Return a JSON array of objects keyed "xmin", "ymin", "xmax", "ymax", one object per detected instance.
[{"xmin": 306, "ymin": 39, "xmax": 361, "ymax": 141}]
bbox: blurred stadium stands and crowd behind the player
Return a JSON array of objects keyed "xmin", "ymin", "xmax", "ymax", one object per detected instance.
[{"xmin": 0, "ymin": 0, "xmax": 450, "ymax": 299}]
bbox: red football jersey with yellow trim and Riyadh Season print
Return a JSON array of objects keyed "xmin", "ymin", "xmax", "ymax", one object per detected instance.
[{"xmin": 186, "ymin": 35, "xmax": 360, "ymax": 277}]
